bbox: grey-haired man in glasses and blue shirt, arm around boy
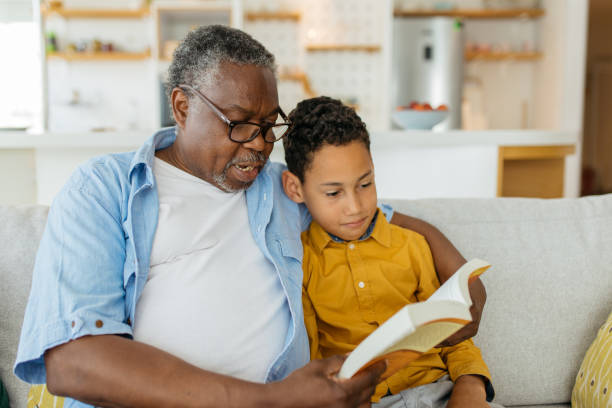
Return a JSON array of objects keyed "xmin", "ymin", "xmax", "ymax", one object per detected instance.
[{"xmin": 15, "ymin": 26, "xmax": 485, "ymax": 407}]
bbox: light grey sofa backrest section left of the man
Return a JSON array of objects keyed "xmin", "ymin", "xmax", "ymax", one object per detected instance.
[{"xmin": 0, "ymin": 206, "xmax": 48, "ymax": 407}]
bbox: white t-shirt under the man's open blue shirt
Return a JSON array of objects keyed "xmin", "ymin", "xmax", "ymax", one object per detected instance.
[{"xmin": 134, "ymin": 158, "xmax": 290, "ymax": 382}]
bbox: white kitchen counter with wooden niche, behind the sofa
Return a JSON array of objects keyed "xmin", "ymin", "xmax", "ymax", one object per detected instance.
[{"xmin": 0, "ymin": 130, "xmax": 580, "ymax": 204}]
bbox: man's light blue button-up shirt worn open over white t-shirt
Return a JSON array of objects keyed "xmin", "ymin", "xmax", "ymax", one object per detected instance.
[{"xmin": 14, "ymin": 128, "xmax": 391, "ymax": 408}]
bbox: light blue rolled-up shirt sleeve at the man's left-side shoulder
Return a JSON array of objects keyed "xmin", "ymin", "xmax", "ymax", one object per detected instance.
[{"xmin": 14, "ymin": 167, "xmax": 132, "ymax": 384}]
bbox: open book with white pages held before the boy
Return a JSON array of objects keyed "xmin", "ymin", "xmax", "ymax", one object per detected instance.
[{"xmin": 338, "ymin": 259, "xmax": 491, "ymax": 380}]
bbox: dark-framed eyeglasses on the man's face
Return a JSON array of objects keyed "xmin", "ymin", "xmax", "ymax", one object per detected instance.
[{"xmin": 179, "ymin": 84, "xmax": 291, "ymax": 143}]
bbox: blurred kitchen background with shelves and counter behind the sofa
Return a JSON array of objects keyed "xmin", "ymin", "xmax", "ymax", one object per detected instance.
[{"xmin": 0, "ymin": 0, "xmax": 612, "ymax": 204}]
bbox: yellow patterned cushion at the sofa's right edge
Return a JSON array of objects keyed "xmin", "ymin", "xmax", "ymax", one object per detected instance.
[{"xmin": 572, "ymin": 313, "xmax": 612, "ymax": 408}]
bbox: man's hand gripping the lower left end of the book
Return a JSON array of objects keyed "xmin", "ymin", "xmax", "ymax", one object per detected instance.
[{"xmin": 269, "ymin": 356, "xmax": 386, "ymax": 408}]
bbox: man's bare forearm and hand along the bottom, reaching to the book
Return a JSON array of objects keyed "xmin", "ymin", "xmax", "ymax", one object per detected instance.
[{"xmin": 45, "ymin": 335, "xmax": 385, "ymax": 408}]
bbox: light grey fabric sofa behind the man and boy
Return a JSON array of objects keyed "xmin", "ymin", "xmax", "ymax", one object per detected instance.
[{"xmin": 0, "ymin": 195, "xmax": 612, "ymax": 407}]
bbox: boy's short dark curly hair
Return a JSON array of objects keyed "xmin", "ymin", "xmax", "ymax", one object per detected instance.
[{"xmin": 283, "ymin": 96, "xmax": 370, "ymax": 182}]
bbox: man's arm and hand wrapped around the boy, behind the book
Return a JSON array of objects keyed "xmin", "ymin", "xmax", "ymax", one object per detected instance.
[{"xmin": 391, "ymin": 211, "xmax": 487, "ymax": 346}]
